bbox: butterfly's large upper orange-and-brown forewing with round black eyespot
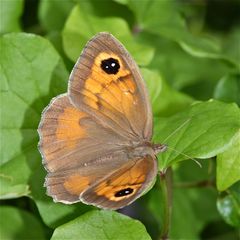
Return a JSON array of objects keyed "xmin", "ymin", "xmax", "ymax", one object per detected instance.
[{"xmin": 68, "ymin": 33, "xmax": 152, "ymax": 142}]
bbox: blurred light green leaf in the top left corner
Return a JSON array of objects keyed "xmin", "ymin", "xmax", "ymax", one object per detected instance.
[{"xmin": 0, "ymin": 0, "xmax": 23, "ymax": 34}]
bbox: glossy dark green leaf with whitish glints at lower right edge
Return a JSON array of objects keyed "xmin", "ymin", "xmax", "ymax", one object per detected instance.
[{"xmin": 217, "ymin": 181, "xmax": 240, "ymax": 228}]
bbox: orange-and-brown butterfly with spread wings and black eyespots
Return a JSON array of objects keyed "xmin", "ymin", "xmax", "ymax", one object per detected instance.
[{"xmin": 38, "ymin": 32, "xmax": 166, "ymax": 209}]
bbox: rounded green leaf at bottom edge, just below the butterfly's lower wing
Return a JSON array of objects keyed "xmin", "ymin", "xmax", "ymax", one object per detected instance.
[{"xmin": 51, "ymin": 210, "xmax": 151, "ymax": 240}]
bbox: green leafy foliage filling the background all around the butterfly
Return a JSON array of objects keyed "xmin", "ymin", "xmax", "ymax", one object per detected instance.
[{"xmin": 0, "ymin": 0, "xmax": 240, "ymax": 240}]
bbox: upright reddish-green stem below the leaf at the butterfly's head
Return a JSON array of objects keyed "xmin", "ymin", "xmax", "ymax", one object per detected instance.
[{"xmin": 159, "ymin": 168, "xmax": 172, "ymax": 240}]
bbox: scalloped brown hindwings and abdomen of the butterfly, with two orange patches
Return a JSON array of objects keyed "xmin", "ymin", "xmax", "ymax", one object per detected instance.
[{"xmin": 38, "ymin": 95, "xmax": 131, "ymax": 203}]
